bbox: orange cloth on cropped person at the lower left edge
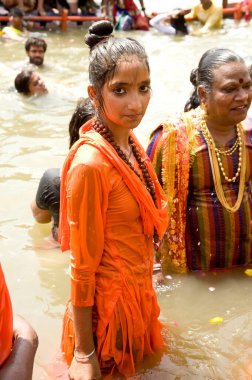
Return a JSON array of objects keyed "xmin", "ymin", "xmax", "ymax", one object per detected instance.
[{"xmin": 0, "ymin": 264, "xmax": 13, "ymax": 366}]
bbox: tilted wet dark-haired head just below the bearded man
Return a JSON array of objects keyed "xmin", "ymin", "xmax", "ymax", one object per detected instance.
[{"xmin": 14, "ymin": 70, "xmax": 48, "ymax": 96}]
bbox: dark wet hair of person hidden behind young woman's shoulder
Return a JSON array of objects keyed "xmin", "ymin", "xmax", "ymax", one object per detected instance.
[{"xmin": 69, "ymin": 98, "xmax": 94, "ymax": 148}]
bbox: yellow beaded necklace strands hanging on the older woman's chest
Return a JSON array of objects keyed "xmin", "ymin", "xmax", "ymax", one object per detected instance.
[{"xmin": 199, "ymin": 115, "xmax": 246, "ymax": 212}]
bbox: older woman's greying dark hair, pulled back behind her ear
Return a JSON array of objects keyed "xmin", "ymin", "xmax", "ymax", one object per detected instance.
[{"xmin": 184, "ymin": 48, "xmax": 244, "ymax": 112}]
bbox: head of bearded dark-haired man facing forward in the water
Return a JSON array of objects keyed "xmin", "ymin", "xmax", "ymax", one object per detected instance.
[{"xmin": 25, "ymin": 37, "xmax": 47, "ymax": 67}]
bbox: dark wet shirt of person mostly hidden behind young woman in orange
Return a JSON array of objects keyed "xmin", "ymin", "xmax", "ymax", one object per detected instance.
[{"xmin": 36, "ymin": 168, "xmax": 60, "ymax": 240}]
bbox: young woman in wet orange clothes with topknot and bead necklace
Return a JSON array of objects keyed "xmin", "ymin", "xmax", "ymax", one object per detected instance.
[{"xmin": 59, "ymin": 21, "xmax": 167, "ymax": 380}]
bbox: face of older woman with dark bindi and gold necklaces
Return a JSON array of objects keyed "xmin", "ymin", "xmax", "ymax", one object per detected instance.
[{"xmin": 204, "ymin": 62, "xmax": 252, "ymax": 126}]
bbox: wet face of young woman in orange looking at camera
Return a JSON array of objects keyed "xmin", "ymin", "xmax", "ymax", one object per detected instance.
[{"xmin": 98, "ymin": 56, "xmax": 151, "ymax": 133}]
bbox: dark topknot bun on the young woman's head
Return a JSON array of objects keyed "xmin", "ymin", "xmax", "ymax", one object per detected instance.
[{"xmin": 85, "ymin": 20, "xmax": 114, "ymax": 48}]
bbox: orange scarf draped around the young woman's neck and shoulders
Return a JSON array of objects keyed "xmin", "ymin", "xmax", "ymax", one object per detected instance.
[{"xmin": 59, "ymin": 120, "xmax": 168, "ymax": 252}]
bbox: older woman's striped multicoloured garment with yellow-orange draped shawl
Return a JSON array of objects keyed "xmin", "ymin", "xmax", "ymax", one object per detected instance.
[{"xmin": 147, "ymin": 110, "xmax": 252, "ymax": 271}]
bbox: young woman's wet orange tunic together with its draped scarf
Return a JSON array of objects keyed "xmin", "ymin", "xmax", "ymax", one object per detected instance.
[{"xmin": 59, "ymin": 122, "xmax": 167, "ymax": 376}]
